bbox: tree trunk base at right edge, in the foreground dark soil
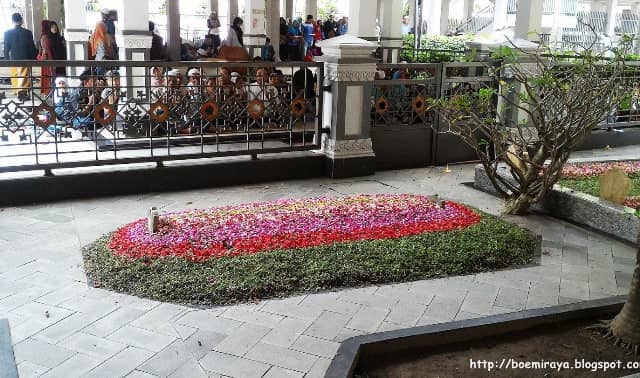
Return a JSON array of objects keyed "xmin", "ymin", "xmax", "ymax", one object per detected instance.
[{"xmin": 610, "ymin": 238, "xmax": 640, "ymax": 351}]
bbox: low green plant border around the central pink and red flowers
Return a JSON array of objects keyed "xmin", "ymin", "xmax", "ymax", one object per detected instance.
[{"xmin": 83, "ymin": 214, "xmax": 536, "ymax": 305}]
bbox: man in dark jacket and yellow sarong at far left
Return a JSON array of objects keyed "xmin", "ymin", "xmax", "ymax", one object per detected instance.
[{"xmin": 4, "ymin": 13, "xmax": 38, "ymax": 100}]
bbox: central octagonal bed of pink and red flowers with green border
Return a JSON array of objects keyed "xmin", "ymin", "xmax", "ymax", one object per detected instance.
[{"xmin": 84, "ymin": 195, "xmax": 535, "ymax": 304}]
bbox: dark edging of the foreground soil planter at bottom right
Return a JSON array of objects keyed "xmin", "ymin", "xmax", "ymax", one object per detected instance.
[{"xmin": 325, "ymin": 296, "xmax": 625, "ymax": 378}]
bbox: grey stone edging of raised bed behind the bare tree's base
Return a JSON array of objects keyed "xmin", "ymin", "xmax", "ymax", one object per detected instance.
[{"xmin": 474, "ymin": 165, "xmax": 640, "ymax": 244}]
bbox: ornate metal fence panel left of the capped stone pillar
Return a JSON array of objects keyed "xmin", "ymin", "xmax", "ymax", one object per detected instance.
[{"xmin": 0, "ymin": 61, "xmax": 323, "ymax": 172}]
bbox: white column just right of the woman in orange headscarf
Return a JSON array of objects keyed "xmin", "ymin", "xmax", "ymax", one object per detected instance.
[{"xmin": 114, "ymin": 0, "xmax": 151, "ymax": 98}]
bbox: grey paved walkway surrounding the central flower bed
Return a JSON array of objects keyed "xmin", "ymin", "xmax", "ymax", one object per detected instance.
[{"xmin": 0, "ymin": 148, "xmax": 635, "ymax": 378}]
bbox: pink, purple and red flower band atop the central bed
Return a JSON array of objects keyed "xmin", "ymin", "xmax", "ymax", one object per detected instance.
[{"xmin": 109, "ymin": 195, "xmax": 480, "ymax": 260}]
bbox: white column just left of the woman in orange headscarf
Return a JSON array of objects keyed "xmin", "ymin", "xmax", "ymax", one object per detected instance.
[{"xmin": 64, "ymin": 0, "xmax": 89, "ymax": 76}]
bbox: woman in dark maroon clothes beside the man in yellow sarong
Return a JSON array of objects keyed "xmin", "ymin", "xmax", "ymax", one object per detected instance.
[{"xmin": 40, "ymin": 20, "xmax": 67, "ymax": 94}]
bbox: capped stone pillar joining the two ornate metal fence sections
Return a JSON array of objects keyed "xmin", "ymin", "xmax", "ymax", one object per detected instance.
[{"xmin": 316, "ymin": 35, "xmax": 377, "ymax": 178}]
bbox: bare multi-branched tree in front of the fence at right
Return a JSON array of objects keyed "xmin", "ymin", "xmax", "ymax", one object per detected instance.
[{"xmin": 434, "ymin": 39, "xmax": 633, "ymax": 214}]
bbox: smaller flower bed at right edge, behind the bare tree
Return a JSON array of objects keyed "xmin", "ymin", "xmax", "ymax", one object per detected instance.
[{"xmin": 558, "ymin": 161, "xmax": 640, "ymax": 209}]
